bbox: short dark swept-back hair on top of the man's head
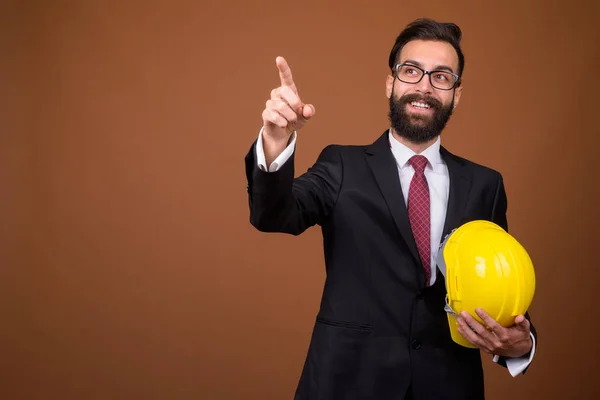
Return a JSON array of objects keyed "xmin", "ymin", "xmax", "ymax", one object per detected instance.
[{"xmin": 389, "ymin": 18, "xmax": 465, "ymax": 80}]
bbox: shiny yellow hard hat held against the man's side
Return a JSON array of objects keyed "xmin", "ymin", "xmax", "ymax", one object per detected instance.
[{"xmin": 437, "ymin": 220, "xmax": 535, "ymax": 348}]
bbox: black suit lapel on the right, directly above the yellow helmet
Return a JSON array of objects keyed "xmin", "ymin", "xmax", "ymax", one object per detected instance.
[{"xmin": 440, "ymin": 146, "xmax": 471, "ymax": 241}]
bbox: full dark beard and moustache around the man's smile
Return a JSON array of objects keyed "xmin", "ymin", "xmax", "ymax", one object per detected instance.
[{"xmin": 388, "ymin": 93, "xmax": 454, "ymax": 144}]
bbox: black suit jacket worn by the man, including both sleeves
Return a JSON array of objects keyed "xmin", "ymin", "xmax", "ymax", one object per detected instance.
[{"xmin": 246, "ymin": 131, "xmax": 535, "ymax": 400}]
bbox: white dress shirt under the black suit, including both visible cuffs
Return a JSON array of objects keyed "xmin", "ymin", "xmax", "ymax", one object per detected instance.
[{"xmin": 256, "ymin": 129, "xmax": 535, "ymax": 377}]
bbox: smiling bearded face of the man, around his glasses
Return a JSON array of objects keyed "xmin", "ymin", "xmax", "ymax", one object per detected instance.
[{"xmin": 386, "ymin": 40, "xmax": 462, "ymax": 144}]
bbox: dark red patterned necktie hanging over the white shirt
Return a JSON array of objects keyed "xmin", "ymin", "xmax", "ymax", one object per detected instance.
[{"xmin": 408, "ymin": 155, "xmax": 431, "ymax": 286}]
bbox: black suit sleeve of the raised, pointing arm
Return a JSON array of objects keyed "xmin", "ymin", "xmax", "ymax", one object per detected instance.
[{"xmin": 245, "ymin": 142, "xmax": 343, "ymax": 235}]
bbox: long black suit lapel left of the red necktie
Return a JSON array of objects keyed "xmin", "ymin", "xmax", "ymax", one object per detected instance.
[{"xmin": 366, "ymin": 131, "xmax": 421, "ymax": 263}]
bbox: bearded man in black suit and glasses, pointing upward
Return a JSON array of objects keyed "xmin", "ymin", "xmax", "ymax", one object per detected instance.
[{"xmin": 245, "ymin": 19, "xmax": 537, "ymax": 400}]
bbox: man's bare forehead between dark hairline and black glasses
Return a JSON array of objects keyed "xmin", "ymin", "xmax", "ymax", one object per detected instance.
[{"xmin": 398, "ymin": 40, "xmax": 458, "ymax": 73}]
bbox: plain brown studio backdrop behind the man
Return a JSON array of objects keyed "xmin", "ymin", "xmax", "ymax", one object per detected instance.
[{"xmin": 0, "ymin": 0, "xmax": 600, "ymax": 400}]
